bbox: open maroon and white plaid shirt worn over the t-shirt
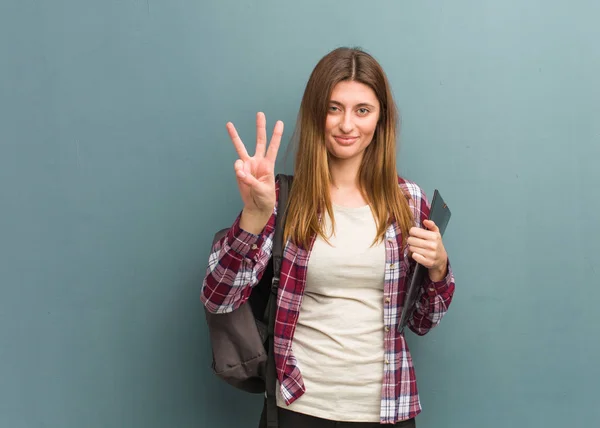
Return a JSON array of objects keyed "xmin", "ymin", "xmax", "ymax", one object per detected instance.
[{"xmin": 201, "ymin": 178, "xmax": 454, "ymax": 424}]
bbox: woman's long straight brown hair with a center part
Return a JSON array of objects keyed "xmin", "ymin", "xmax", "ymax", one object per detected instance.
[{"xmin": 284, "ymin": 48, "xmax": 413, "ymax": 248}]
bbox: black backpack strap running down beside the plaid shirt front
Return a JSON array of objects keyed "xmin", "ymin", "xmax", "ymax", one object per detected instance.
[{"xmin": 265, "ymin": 174, "xmax": 293, "ymax": 428}]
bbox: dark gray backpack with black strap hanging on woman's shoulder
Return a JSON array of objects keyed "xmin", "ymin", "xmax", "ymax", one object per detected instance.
[{"xmin": 204, "ymin": 174, "xmax": 293, "ymax": 428}]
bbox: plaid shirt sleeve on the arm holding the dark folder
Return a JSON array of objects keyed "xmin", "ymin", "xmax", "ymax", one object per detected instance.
[{"xmin": 408, "ymin": 182, "xmax": 455, "ymax": 336}]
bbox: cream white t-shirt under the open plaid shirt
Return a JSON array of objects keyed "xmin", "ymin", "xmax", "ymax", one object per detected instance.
[{"xmin": 277, "ymin": 205, "xmax": 385, "ymax": 422}]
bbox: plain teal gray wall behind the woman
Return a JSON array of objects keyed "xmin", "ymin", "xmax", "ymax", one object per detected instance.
[{"xmin": 0, "ymin": 0, "xmax": 600, "ymax": 428}]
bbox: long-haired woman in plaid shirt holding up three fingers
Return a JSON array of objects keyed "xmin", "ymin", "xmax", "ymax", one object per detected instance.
[{"xmin": 202, "ymin": 48, "xmax": 454, "ymax": 428}]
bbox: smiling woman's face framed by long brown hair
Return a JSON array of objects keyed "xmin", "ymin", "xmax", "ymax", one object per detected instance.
[{"xmin": 325, "ymin": 81, "xmax": 380, "ymax": 165}]
